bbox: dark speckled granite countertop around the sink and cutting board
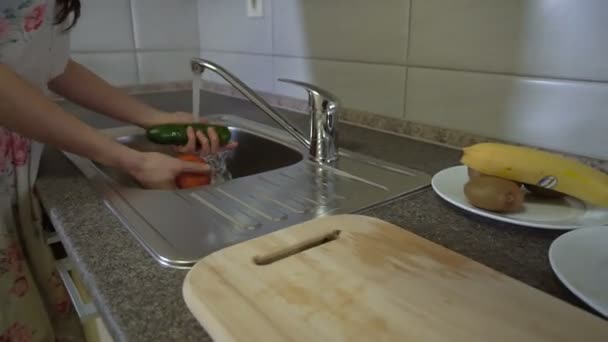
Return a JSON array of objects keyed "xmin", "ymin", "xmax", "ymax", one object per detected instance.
[{"xmin": 36, "ymin": 91, "xmax": 589, "ymax": 341}]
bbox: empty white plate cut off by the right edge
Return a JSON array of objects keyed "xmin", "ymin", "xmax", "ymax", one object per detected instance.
[{"xmin": 549, "ymin": 227, "xmax": 608, "ymax": 317}]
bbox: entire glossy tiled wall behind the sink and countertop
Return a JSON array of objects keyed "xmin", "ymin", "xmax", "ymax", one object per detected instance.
[{"xmin": 66, "ymin": 0, "xmax": 608, "ymax": 158}]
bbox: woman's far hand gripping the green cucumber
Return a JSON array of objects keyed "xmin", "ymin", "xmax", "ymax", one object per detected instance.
[{"xmin": 146, "ymin": 112, "xmax": 237, "ymax": 156}]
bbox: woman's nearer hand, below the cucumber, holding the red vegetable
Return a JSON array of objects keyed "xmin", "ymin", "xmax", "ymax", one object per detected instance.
[{"xmin": 127, "ymin": 152, "xmax": 210, "ymax": 189}]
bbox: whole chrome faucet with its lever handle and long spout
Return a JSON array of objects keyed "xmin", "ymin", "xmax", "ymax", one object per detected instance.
[{"xmin": 190, "ymin": 58, "xmax": 339, "ymax": 163}]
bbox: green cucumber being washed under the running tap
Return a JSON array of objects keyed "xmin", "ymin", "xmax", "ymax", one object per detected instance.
[{"xmin": 146, "ymin": 123, "xmax": 230, "ymax": 146}]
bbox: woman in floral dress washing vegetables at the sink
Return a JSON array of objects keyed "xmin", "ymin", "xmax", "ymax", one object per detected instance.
[{"xmin": 0, "ymin": 0, "xmax": 228, "ymax": 341}]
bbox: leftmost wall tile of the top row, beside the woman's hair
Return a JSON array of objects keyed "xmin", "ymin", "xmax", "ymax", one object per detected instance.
[{"xmin": 70, "ymin": 0, "xmax": 133, "ymax": 51}]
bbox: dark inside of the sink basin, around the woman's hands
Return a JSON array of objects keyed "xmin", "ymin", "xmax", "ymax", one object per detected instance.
[{"xmin": 95, "ymin": 127, "xmax": 303, "ymax": 188}]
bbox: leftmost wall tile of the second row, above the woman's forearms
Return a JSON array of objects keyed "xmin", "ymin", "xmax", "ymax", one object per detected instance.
[{"xmin": 72, "ymin": 52, "xmax": 138, "ymax": 85}]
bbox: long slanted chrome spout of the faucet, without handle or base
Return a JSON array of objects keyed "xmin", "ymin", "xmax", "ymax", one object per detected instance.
[{"xmin": 190, "ymin": 58, "xmax": 310, "ymax": 149}]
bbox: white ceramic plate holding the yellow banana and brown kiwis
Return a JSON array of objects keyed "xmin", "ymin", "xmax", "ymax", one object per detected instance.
[{"xmin": 431, "ymin": 165, "xmax": 608, "ymax": 230}]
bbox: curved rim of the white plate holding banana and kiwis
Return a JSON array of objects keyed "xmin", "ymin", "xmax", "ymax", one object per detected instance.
[{"xmin": 431, "ymin": 165, "xmax": 608, "ymax": 230}]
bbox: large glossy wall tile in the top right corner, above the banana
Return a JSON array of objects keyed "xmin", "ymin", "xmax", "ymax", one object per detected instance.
[{"xmin": 409, "ymin": 0, "xmax": 608, "ymax": 81}]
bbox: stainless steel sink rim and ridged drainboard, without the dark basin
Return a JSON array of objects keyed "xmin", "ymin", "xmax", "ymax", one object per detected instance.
[{"xmin": 66, "ymin": 115, "xmax": 430, "ymax": 268}]
